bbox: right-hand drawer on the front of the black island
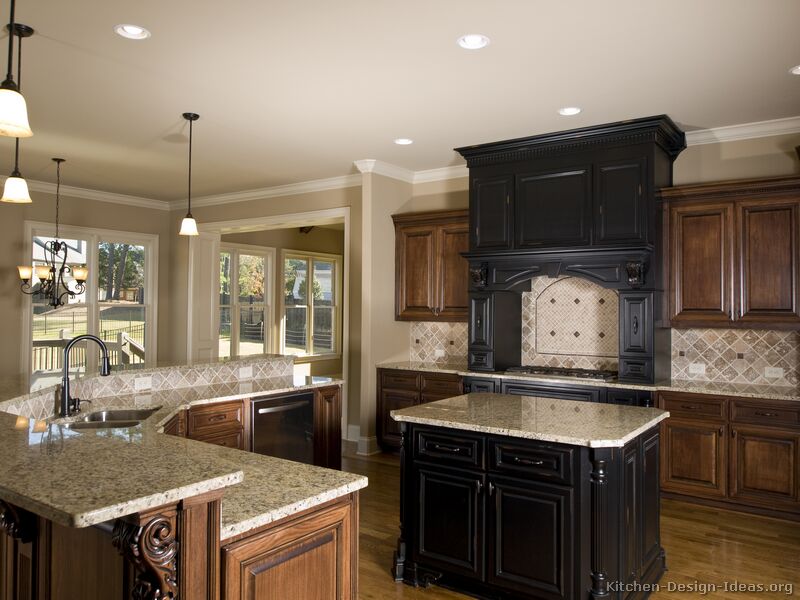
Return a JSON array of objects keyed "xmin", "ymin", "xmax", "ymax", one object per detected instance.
[{"xmin": 489, "ymin": 439, "xmax": 574, "ymax": 485}]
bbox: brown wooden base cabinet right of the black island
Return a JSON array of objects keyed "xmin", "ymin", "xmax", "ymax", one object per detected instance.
[{"xmin": 658, "ymin": 392, "xmax": 800, "ymax": 520}]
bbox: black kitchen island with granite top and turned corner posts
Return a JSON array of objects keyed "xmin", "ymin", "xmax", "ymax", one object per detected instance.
[{"xmin": 392, "ymin": 393, "xmax": 669, "ymax": 600}]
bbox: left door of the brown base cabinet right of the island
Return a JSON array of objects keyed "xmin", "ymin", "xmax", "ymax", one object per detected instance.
[{"xmin": 661, "ymin": 417, "xmax": 728, "ymax": 498}]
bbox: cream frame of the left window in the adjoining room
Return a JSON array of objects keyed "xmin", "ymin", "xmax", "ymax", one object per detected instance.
[{"xmin": 216, "ymin": 242, "xmax": 276, "ymax": 358}]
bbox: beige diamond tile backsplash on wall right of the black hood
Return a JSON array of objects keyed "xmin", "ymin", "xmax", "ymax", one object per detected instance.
[{"xmin": 672, "ymin": 329, "xmax": 800, "ymax": 386}]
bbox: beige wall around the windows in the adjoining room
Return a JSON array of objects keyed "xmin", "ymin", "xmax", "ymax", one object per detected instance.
[{"xmin": 222, "ymin": 227, "xmax": 344, "ymax": 375}]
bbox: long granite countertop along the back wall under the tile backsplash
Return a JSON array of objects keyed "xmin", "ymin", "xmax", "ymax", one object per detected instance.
[{"xmin": 377, "ymin": 361, "xmax": 800, "ymax": 402}]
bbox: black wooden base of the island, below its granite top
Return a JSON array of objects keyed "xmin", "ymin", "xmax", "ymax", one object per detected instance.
[{"xmin": 394, "ymin": 423, "xmax": 664, "ymax": 600}]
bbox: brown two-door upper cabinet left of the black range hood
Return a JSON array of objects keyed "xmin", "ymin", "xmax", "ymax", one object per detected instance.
[{"xmin": 392, "ymin": 210, "xmax": 469, "ymax": 321}]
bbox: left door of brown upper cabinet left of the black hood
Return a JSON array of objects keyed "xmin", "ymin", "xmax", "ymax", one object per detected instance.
[{"xmin": 395, "ymin": 225, "xmax": 438, "ymax": 320}]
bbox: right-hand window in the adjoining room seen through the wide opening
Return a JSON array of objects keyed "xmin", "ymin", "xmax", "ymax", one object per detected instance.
[{"xmin": 281, "ymin": 251, "xmax": 342, "ymax": 356}]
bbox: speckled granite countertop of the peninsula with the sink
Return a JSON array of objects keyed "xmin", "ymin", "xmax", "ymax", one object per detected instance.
[{"xmin": 0, "ymin": 377, "xmax": 367, "ymax": 540}]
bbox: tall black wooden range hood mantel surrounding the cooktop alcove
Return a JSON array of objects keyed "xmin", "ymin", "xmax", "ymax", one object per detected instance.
[{"xmin": 456, "ymin": 115, "xmax": 686, "ymax": 383}]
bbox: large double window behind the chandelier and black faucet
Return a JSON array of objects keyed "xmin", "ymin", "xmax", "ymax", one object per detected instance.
[{"xmin": 23, "ymin": 223, "xmax": 158, "ymax": 390}]
